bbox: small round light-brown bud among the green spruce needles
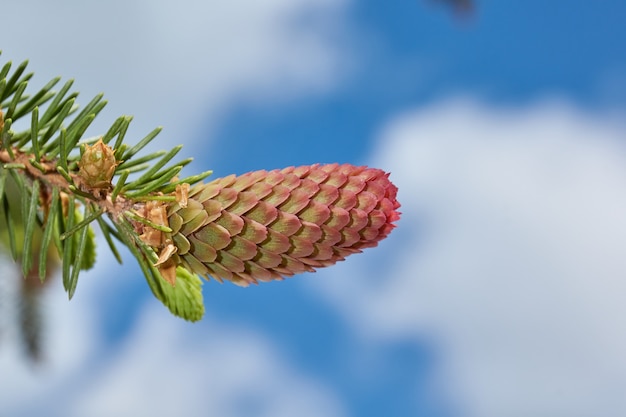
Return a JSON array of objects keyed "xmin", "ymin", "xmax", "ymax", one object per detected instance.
[{"xmin": 78, "ymin": 139, "xmax": 118, "ymax": 188}]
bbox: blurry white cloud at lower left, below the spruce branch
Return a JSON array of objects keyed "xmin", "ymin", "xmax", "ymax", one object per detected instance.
[{"xmin": 0, "ymin": 259, "xmax": 346, "ymax": 417}]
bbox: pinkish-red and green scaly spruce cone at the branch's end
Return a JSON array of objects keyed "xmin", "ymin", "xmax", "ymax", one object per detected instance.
[{"xmin": 160, "ymin": 164, "xmax": 400, "ymax": 286}]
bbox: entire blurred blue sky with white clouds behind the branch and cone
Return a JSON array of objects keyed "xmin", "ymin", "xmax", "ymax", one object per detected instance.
[{"xmin": 0, "ymin": 0, "xmax": 626, "ymax": 417}]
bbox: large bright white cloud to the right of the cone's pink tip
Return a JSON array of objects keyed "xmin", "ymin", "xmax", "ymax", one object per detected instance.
[{"xmin": 309, "ymin": 100, "xmax": 626, "ymax": 417}]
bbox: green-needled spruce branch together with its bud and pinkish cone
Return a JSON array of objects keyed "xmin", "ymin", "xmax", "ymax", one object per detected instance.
[{"xmin": 0, "ymin": 52, "xmax": 400, "ymax": 321}]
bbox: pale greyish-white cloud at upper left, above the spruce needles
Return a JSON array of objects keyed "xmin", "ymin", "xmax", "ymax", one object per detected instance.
[{"xmin": 2, "ymin": 0, "xmax": 349, "ymax": 152}]
